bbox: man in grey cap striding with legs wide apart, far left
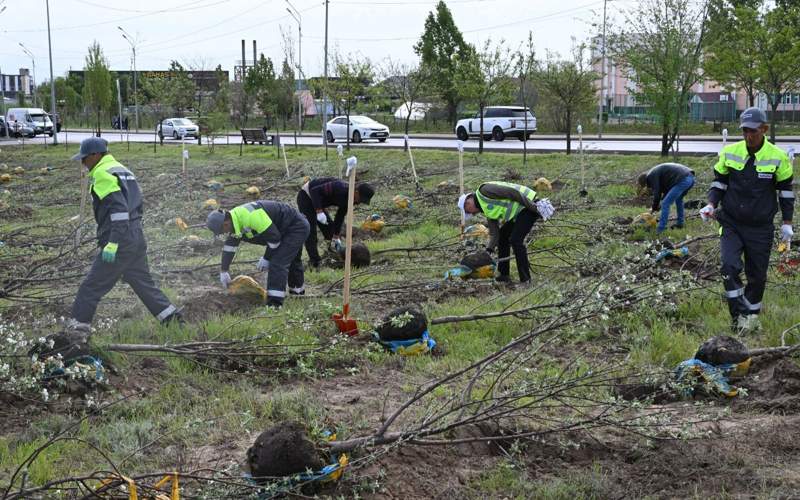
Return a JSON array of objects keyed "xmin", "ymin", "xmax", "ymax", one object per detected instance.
[{"xmin": 67, "ymin": 137, "xmax": 183, "ymax": 333}]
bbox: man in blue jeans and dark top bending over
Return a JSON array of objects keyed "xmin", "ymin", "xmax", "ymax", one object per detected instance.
[{"xmin": 638, "ymin": 163, "xmax": 694, "ymax": 233}]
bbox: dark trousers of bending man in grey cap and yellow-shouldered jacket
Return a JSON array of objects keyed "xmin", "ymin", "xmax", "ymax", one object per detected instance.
[{"xmin": 267, "ymin": 214, "xmax": 309, "ymax": 302}]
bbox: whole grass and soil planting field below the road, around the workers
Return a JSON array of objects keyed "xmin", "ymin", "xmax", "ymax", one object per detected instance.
[{"xmin": 0, "ymin": 144, "xmax": 800, "ymax": 499}]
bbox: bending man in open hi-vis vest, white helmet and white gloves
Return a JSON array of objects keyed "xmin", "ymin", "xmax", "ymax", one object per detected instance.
[{"xmin": 458, "ymin": 181, "xmax": 555, "ymax": 283}]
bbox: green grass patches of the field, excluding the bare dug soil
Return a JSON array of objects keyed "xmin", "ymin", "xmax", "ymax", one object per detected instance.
[{"xmin": 0, "ymin": 143, "xmax": 800, "ymax": 498}]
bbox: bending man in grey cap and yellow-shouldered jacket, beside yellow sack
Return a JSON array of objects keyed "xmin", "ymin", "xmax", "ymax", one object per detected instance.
[{"xmin": 206, "ymin": 200, "xmax": 309, "ymax": 307}]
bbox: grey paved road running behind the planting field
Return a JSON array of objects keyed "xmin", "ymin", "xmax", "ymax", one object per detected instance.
[{"xmin": 6, "ymin": 131, "xmax": 800, "ymax": 155}]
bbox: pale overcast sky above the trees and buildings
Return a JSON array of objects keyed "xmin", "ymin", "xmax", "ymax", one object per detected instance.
[{"xmin": 0, "ymin": 0, "xmax": 633, "ymax": 81}]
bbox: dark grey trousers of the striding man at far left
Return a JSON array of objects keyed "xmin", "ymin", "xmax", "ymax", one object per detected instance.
[{"xmin": 72, "ymin": 220, "xmax": 177, "ymax": 323}]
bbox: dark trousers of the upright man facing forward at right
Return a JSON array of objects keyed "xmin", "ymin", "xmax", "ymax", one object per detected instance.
[{"xmin": 720, "ymin": 220, "xmax": 775, "ymax": 319}]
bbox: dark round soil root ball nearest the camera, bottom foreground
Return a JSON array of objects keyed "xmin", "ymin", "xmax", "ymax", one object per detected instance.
[{"xmin": 247, "ymin": 422, "xmax": 322, "ymax": 480}]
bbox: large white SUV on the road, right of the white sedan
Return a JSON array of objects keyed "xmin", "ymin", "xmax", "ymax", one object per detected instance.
[{"xmin": 455, "ymin": 106, "xmax": 536, "ymax": 141}]
